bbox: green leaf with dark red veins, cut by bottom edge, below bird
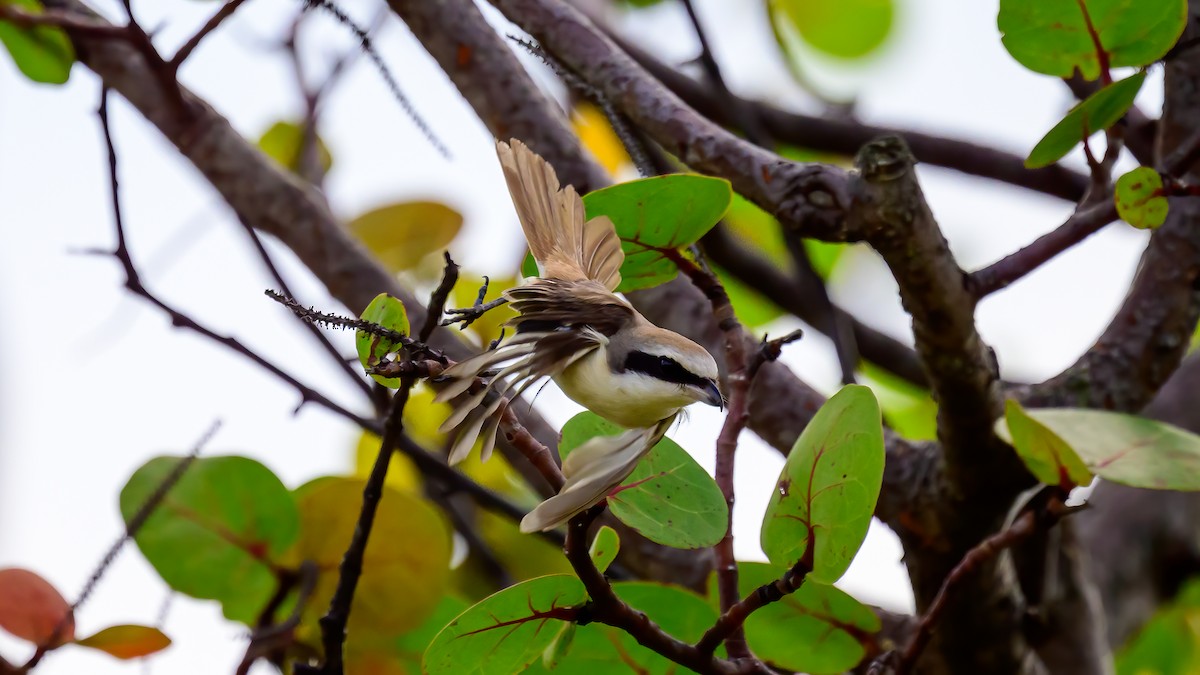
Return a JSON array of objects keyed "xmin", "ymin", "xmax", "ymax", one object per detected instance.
[{"xmin": 425, "ymin": 574, "xmax": 587, "ymax": 675}]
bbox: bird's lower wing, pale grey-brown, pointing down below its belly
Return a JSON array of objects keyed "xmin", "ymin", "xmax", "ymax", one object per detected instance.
[{"xmin": 521, "ymin": 416, "xmax": 674, "ymax": 532}]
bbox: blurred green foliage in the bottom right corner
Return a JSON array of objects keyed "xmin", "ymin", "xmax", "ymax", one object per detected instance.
[{"xmin": 1116, "ymin": 579, "xmax": 1200, "ymax": 675}]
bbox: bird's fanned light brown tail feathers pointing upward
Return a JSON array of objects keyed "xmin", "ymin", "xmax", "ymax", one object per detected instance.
[{"xmin": 496, "ymin": 139, "xmax": 625, "ymax": 291}]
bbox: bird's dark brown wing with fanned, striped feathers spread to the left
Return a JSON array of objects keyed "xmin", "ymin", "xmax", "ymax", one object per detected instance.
[{"xmin": 436, "ymin": 279, "xmax": 635, "ymax": 464}]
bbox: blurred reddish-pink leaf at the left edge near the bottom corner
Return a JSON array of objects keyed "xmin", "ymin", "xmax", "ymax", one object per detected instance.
[{"xmin": 0, "ymin": 567, "xmax": 74, "ymax": 646}]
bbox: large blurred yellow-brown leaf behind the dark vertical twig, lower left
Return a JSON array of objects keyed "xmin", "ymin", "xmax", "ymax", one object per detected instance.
[{"xmin": 288, "ymin": 477, "xmax": 450, "ymax": 641}]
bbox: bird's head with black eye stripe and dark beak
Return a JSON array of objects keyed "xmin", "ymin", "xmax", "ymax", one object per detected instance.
[{"xmin": 608, "ymin": 322, "xmax": 725, "ymax": 407}]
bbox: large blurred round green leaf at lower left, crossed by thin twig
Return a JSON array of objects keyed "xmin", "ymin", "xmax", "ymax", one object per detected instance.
[{"xmin": 120, "ymin": 456, "xmax": 300, "ymax": 626}]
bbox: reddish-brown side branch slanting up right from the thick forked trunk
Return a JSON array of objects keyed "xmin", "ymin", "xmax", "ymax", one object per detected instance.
[{"xmin": 968, "ymin": 197, "xmax": 1117, "ymax": 299}]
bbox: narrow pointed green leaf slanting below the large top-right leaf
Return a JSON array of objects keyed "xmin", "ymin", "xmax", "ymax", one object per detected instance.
[{"xmin": 1025, "ymin": 72, "xmax": 1146, "ymax": 168}]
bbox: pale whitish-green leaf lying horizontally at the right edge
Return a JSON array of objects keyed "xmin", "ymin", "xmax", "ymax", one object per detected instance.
[{"xmin": 996, "ymin": 408, "xmax": 1200, "ymax": 491}]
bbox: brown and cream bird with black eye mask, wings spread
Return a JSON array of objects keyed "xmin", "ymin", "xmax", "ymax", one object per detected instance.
[{"xmin": 436, "ymin": 139, "xmax": 724, "ymax": 532}]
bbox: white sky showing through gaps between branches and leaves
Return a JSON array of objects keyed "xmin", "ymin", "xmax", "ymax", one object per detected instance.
[{"xmin": 0, "ymin": 0, "xmax": 1160, "ymax": 675}]
